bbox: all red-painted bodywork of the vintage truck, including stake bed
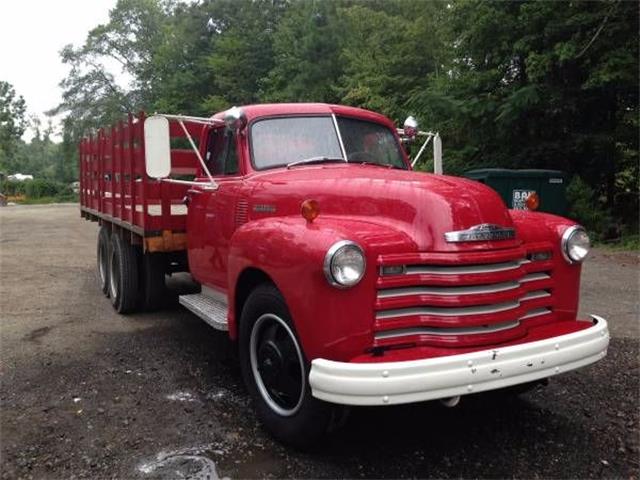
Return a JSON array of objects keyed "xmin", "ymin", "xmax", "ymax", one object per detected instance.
[{"xmin": 80, "ymin": 104, "xmax": 590, "ymax": 362}]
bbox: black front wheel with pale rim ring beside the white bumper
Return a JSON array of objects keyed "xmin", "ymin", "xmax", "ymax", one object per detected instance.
[{"xmin": 239, "ymin": 284, "xmax": 338, "ymax": 448}]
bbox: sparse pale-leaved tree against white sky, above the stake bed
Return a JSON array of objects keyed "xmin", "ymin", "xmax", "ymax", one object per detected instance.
[{"xmin": 51, "ymin": 0, "xmax": 172, "ymax": 139}]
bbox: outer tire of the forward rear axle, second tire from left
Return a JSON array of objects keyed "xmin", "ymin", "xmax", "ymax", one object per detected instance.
[{"xmin": 109, "ymin": 234, "xmax": 138, "ymax": 313}]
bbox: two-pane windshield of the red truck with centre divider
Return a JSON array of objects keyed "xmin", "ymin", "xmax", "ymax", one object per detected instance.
[{"xmin": 251, "ymin": 116, "xmax": 407, "ymax": 170}]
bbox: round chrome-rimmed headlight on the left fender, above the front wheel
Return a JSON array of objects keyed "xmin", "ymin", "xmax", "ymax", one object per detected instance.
[{"xmin": 324, "ymin": 240, "xmax": 366, "ymax": 288}]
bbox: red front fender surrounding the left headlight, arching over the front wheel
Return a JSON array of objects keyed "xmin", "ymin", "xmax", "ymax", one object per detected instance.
[{"xmin": 228, "ymin": 216, "xmax": 415, "ymax": 361}]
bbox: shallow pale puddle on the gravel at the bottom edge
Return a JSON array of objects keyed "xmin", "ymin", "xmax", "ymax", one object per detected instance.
[{"xmin": 138, "ymin": 445, "xmax": 229, "ymax": 480}]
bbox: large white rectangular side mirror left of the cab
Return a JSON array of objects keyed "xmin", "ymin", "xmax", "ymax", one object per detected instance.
[{"xmin": 144, "ymin": 115, "xmax": 171, "ymax": 178}]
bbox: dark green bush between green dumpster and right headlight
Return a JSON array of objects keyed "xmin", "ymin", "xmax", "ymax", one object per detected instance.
[{"xmin": 567, "ymin": 175, "xmax": 612, "ymax": 239}]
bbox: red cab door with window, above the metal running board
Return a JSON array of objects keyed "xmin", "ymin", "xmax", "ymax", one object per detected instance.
[{"xmin": 187, "ymin": 127, "xmax": 243, "ymax": 292}]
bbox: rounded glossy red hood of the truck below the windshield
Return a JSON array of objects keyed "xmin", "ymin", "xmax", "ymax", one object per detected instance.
[{"xmin": 250, "ymin": 164, "xmax": 514, "ymax": 251}]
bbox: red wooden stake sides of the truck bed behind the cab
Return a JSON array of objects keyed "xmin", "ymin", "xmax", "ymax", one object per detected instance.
[{"xmin": 79, "ymin": 112, "xmax": 203, "ymax": 251}]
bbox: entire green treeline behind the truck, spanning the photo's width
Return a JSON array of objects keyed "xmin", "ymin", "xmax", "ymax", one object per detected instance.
[{"xmin": 0, "ymin": 0, "xmax": 640, "ymax": 240}]
